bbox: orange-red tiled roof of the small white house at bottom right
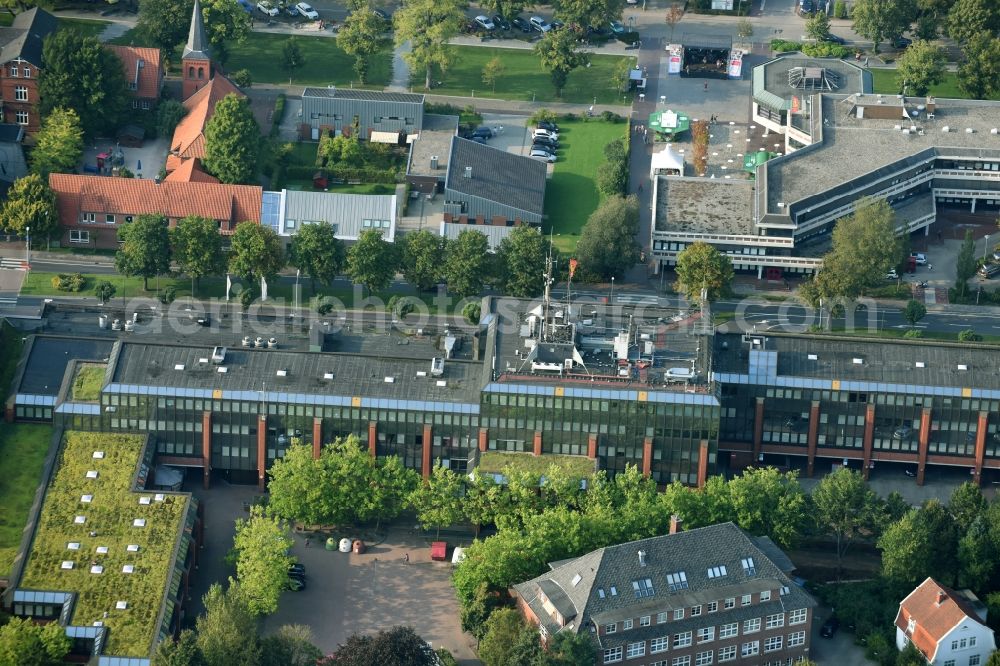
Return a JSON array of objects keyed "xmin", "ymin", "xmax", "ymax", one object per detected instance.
[{"xmin": 896, "ymin": 578, "xmax": 982, "ymax": 659}]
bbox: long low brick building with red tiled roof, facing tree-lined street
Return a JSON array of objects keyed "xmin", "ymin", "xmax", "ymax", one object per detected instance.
[{"xmin": 49, "ymin": 173, "xmax": 263, "ymax": 249}]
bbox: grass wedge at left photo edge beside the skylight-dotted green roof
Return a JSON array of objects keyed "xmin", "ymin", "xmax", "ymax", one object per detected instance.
[{"xmin": 0, "ymin": 423, "xmax": 52, "ymax": 576}]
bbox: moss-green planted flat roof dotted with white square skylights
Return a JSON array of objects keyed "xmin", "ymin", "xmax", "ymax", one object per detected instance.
[{"xmin": 19, "ymin": 432, "xmax": 189, "ymax": 657}]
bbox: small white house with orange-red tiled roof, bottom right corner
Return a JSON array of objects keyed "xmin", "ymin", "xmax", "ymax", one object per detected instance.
[{"xmin": 896, "ymin": 578, "xmax": 996, "ymax": 666}]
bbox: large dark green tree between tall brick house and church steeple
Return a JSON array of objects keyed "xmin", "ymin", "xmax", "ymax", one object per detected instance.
[{"xmin": 38, "ymin": 30, "xmax": 131, "ymax": 137}]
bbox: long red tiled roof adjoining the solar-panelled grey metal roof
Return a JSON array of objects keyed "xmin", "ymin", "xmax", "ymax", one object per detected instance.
[{"xmin": 49, "ymin": 173, "xmax": 263, "ymax": 226}]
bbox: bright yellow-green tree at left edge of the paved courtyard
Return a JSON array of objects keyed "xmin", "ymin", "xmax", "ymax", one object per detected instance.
[{"xmin": 233, "ymin": 506, "xmax": 295, "ymax": 615}]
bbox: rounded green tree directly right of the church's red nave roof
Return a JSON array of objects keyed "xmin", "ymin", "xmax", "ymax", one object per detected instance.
[{"xmin": 204, "ymin": 92, "xmax": 260, "ymax": 185}]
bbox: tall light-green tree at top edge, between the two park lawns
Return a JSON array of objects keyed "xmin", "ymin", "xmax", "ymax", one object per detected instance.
[{"xmin": 392, "ymin": 0, "xmax": 465, "ymax": 90}]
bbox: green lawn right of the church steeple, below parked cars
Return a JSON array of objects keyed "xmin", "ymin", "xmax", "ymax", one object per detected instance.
[{"xmin": 226, "ymin": 32, "xmax": 392, "ymax": 88}]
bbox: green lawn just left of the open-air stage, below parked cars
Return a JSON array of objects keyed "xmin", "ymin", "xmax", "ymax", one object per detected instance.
[{"xmin": 426, "ymin": 46, "xmax": 635, "ymax": 104}]
